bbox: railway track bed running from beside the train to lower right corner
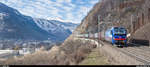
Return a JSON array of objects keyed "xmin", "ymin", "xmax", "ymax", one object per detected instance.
[{"xmin": 77, "ymin": 39, "xmax": 150, "ymax": 65}]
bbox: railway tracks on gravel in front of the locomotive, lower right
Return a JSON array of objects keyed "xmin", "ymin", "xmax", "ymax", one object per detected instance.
[{"xmin": 106, "ymin": 42, "xmax": 150, "ymax": 65}]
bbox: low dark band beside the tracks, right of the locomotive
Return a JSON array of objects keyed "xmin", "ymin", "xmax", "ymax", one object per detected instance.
[{"xmin": 127, "ymin": 39, "xmax": 149, "ymax": 47}]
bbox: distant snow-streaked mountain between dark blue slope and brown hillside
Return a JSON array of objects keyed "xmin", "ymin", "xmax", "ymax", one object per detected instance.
[{"xmin": 34, "ymin": 19, "xmax": 76, "ymax": 40}]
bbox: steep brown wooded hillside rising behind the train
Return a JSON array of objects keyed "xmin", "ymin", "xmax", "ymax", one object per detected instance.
[{"xmin": 74, "ymin": 0, "xmax": 150, "ymax": 40}]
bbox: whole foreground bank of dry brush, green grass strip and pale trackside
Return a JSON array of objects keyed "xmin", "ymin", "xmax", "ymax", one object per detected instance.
[{"xmin": 0, "ymin": 38, "xmax": 145, "ymax": 65}]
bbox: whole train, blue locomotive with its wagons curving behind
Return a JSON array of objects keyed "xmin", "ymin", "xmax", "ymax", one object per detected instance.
[{"xmin": 77, "ymin": 27, "xmax": 127, "ymax": 46}]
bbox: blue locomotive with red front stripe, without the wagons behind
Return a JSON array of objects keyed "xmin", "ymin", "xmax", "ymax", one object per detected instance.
[{"xmin": 105, "ymin": 27, "xmax": 127, "ymax": 46}]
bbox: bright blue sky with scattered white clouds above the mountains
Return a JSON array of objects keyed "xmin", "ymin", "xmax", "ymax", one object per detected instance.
[{"xmin": 0, "ymin": 0, "xmax": 99, "ymax": 23}]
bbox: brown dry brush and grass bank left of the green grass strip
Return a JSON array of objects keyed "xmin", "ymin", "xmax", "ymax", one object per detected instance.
[{"xmin": 1, "ymin": 40, "xmax": 96, "ymax": 65}]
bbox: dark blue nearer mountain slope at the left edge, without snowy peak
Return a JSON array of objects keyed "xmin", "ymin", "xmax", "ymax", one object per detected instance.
[{"xmin": 0, "ymin": 3, "xmax": 50, "ymax": 40}]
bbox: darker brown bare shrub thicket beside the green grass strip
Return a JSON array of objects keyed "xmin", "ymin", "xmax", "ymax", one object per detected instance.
[{"xmin": 61, "ymin": 40, "xmax": 95, "ymax": 64}]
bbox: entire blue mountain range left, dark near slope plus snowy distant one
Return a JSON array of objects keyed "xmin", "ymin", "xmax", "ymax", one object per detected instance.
[{"xmin": 0, "ymin": 3, "xmax": 77, "ymax": 41}]
